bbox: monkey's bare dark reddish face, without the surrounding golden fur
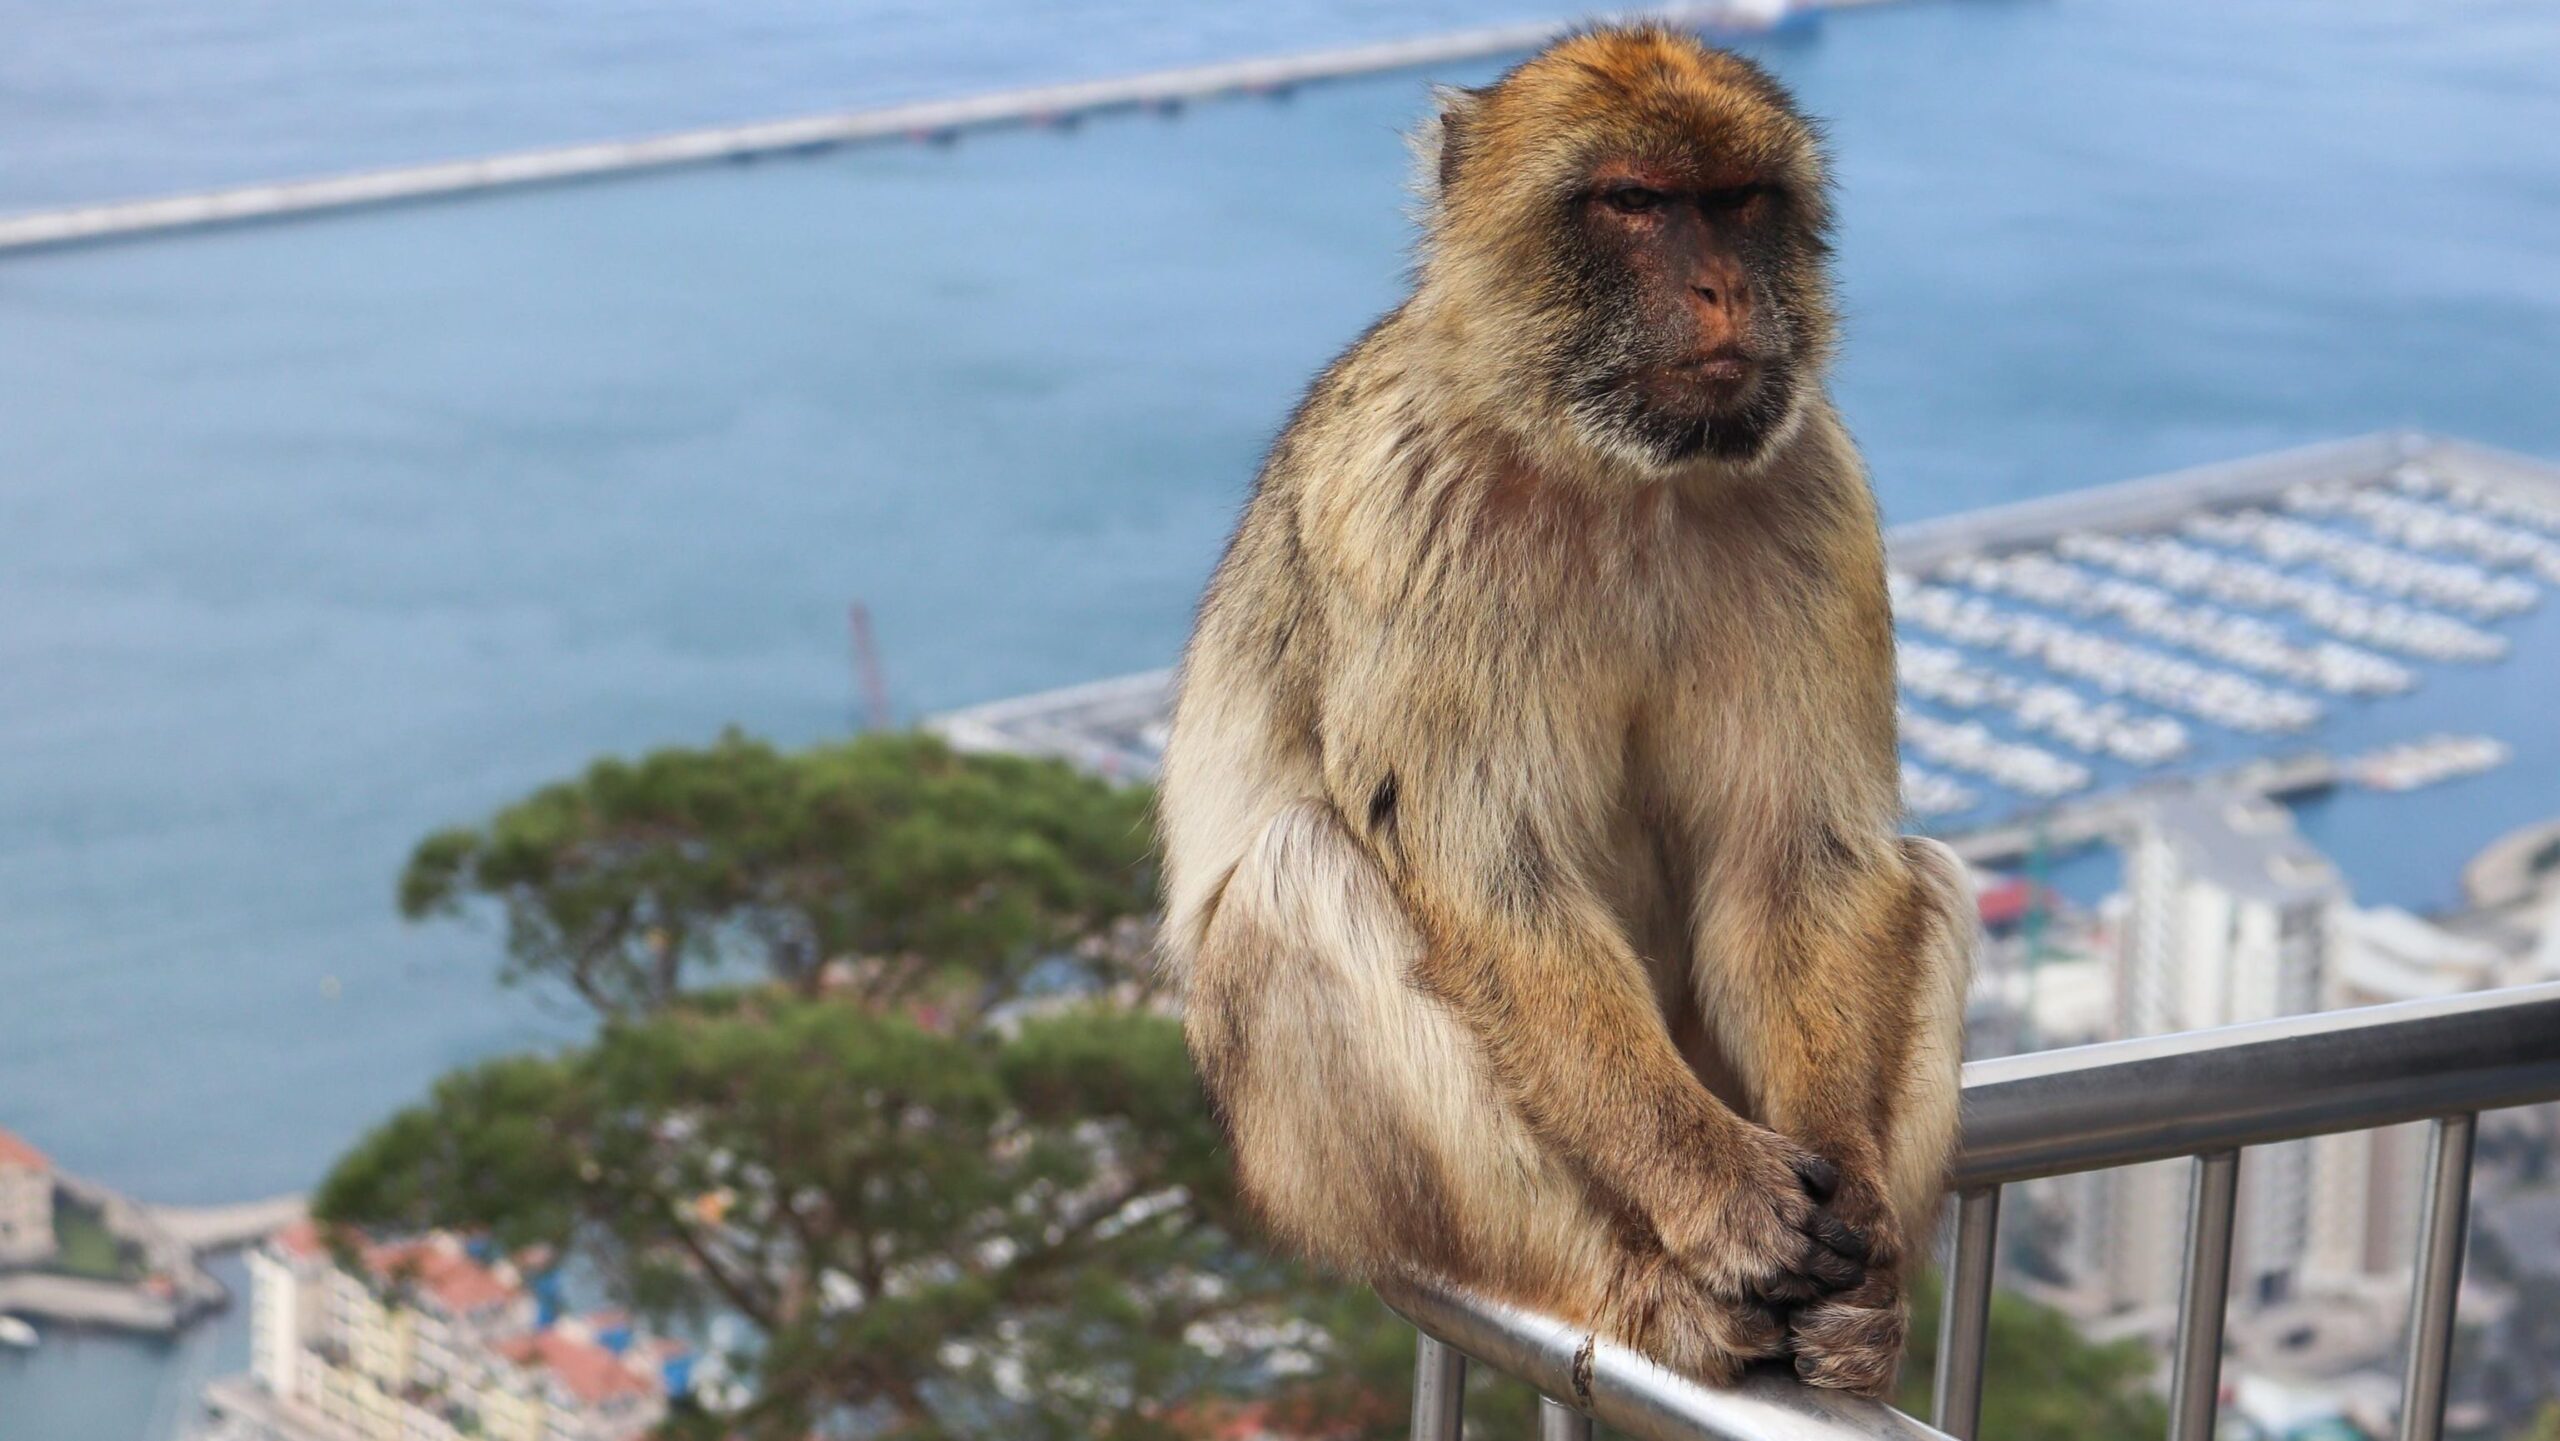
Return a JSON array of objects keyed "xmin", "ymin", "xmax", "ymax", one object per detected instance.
[{"xmin": 1564, "ymin": 156, "xmax": 1810, "ymax": 463}]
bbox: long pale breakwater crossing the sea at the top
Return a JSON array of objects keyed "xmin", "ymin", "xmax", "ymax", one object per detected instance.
[{"xmin": 0, "ymin": 0, "xmax": 1882, "ymax": 256}]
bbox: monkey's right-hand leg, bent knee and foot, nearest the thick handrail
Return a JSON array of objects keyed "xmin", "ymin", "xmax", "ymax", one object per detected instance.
[{"xmin": 1700, "ymin": 837, "xmax": 1976, "ymax": 1395}]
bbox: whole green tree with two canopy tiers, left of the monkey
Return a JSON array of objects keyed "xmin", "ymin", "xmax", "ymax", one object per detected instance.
[{"xmin": 315, "ymin": 735, "xmax": 1403, "ymax": 1441}]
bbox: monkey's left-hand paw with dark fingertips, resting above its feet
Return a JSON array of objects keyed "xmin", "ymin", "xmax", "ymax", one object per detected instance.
[{"xmin": 1654, "ymin": 1124, "xmax": 1871, "ymax": 1313}]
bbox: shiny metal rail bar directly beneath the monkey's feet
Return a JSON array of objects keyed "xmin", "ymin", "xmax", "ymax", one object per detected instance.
[{"xmin": 1377, "ymin": 1280, "xmax": 1948, "ymax": 1441}]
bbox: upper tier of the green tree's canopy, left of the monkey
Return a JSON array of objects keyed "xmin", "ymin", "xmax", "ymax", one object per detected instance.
[{"xmin": 399, "ymin": 732, "xmax": 1155, "ymax": 1016}]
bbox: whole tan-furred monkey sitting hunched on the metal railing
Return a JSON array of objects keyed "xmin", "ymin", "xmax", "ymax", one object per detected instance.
[{"xmin": 1157, "ymin": 26, "xmax": 1976, "ymax": 1400}]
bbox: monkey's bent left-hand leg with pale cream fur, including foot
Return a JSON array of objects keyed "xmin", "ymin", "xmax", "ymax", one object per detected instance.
[{"xmin": 1185, "ymin": 804, "xmax": 1782, "ymax": 1382}]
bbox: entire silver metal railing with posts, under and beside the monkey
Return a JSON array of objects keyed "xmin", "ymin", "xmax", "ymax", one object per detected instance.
[{"xmin": 1380, "ymin": 983, "xmax": 2560, "ymax": 1441}]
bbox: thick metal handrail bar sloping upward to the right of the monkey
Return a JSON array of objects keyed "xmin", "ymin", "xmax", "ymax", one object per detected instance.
[{"xmin": 1951, "ymin": 983, "xmax": 2560, "ymax": 1190}]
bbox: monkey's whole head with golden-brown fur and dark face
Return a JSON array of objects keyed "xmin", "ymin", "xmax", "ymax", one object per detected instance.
[{"xmin": 1418, "ymin": 26, "xmax": 1833, "ymax": 474}]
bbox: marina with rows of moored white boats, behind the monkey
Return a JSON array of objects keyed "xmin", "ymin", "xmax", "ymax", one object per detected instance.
[{"xmin": 929, "ymin": 435, "xmax": 2560, "ymax": 860}]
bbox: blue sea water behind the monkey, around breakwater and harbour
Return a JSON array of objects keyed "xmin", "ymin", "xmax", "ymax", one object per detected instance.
[{"xmin": 0, "ymin": 0, "xmax": 2560, "ymax": 1441}]
